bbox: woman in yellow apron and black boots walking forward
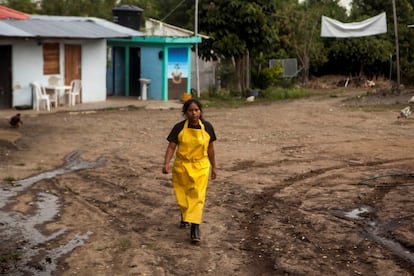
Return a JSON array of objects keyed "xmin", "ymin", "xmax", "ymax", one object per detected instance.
[{"xmin": 162, "ymin": 99, "xmax": 216, "ymax": 243}]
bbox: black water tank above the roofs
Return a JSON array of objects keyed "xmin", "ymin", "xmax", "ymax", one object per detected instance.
[{"xmin": 112, "ymin": 5, "xmax": 144, "ymax": 30}]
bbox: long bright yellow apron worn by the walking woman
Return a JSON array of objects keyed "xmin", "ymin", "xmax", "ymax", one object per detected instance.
[{"xmin": 172, "ymin": 120, "xmax": 210, "ymax": 224}]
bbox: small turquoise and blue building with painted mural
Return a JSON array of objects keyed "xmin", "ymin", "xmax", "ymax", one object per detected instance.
[{"xmin": 107, "ymin": 35, "xmax": 201, "ymax": 101}]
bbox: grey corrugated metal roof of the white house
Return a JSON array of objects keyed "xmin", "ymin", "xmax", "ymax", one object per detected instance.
[{"xmin": 0, "ymin": 15, "xmax": 144, "ymax": 39}]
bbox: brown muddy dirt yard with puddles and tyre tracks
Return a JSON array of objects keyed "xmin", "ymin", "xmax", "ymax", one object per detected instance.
[{"xmin": 0, "ymin": 87, "xmax": 414, "ymax": 275}]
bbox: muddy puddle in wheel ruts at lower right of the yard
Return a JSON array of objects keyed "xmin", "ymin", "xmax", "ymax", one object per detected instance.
[{"xmin": 331, "ymin": 206, "xmax": 414, "ymax": 265}]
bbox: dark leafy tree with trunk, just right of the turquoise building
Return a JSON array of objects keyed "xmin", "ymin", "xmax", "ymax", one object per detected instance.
[{"xmin": 199, "ymin": 0, "xmax": 277, "ymax": 91}]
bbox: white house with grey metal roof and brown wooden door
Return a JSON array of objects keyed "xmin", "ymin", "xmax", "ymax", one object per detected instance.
[{"xmin": 0, "ymin": 6, "xmax": 143, "ymax": 109}]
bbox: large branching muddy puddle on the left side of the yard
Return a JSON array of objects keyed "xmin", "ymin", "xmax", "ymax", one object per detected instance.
[{"xmin": 0, "ymin": 151, "xmax": 106, "ymax": 275}]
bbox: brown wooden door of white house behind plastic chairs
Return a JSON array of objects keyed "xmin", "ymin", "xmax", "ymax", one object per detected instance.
[{"xmin": 65, "ymin": 44, "xmax": 82, "ymax": 102}]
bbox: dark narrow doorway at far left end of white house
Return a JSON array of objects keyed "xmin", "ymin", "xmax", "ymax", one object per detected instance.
[{"xmin": 0, "ymin": 45, "xmax": 12, "ymax": 109}]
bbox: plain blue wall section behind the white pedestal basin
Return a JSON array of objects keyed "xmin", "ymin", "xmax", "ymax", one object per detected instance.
[{"xmin": 141, "ymin": 47, "xmax": 163, "ymax": 100}]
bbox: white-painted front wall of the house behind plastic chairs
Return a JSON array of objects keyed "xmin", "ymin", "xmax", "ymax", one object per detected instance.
[{"xmin": 6, "ymin": 39, "xmax": 106, "ymax": 107}]
